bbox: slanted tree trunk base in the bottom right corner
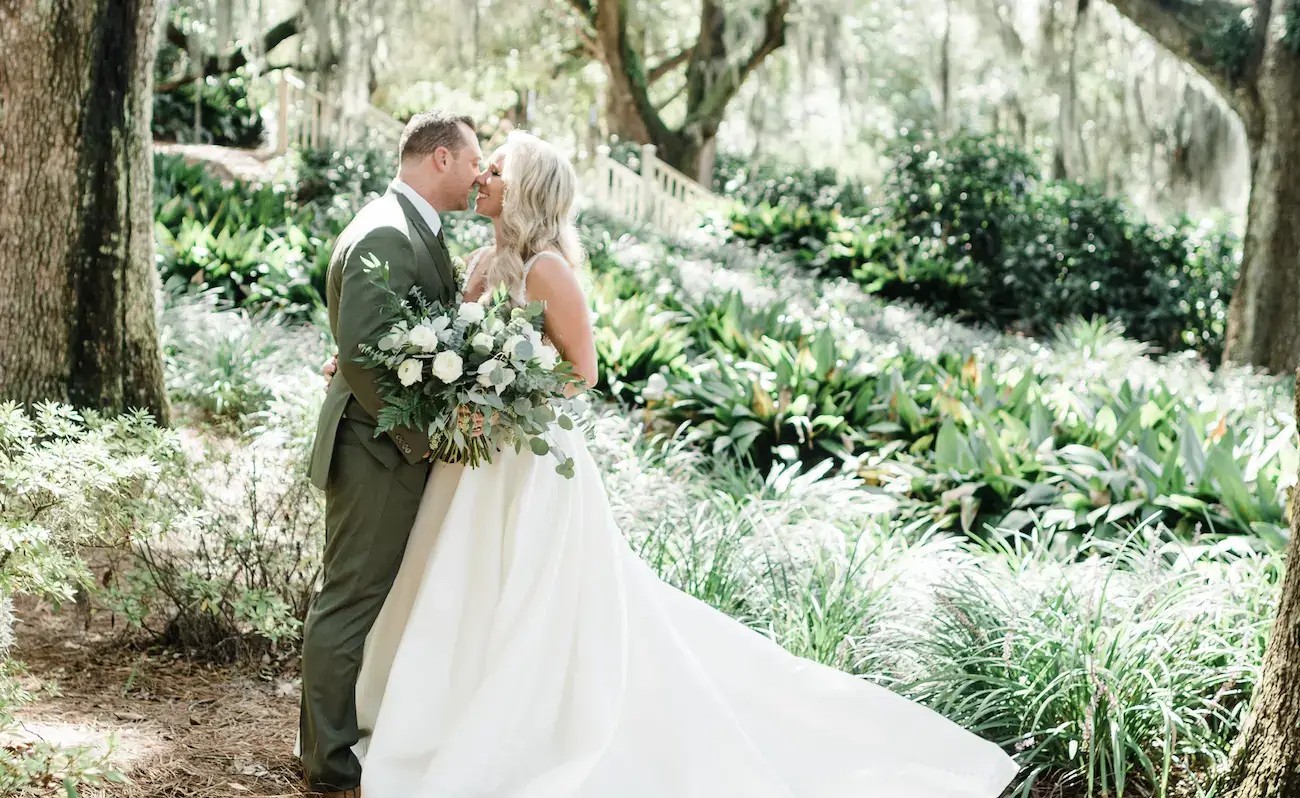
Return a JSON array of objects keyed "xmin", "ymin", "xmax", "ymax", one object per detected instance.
[{"xmin": 1223, "ymin": 376, "xmax": 1300, "ymax": 798}]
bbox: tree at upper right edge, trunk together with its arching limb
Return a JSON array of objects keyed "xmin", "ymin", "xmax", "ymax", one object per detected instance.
[{"xmin": 1110, "ymin": 0, "xmax": 1300, "ymax": 373}]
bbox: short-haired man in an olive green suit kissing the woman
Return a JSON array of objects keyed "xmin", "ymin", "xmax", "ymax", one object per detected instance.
[{"xmin": 299, "ymin": 110, "xmax": 482, "ymax": 798}]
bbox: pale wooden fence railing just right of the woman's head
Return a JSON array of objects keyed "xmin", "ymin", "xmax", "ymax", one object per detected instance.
[{"xmin": 590, "ymin": 144, "xmax": 719, "ymax": 235}]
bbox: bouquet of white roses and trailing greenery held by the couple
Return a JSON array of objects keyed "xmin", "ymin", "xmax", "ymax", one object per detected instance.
[{"xmin": 356, "ymin": 259, "xmax": 584, "ymax": 478}]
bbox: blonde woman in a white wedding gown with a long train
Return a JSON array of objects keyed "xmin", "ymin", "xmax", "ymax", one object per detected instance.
[{"xmin": 327, "ymin": 133, "xmax": 1017, "ymax": 798}]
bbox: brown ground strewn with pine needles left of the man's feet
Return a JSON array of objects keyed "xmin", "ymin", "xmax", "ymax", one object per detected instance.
[{"xmin": 5, "ymin": 603, "xmax": 304, "ymax": 798}]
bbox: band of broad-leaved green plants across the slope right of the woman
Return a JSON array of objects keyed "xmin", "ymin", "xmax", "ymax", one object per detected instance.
[{"xmin": 592, "ymin": 215, "xmax": 1297, "ymax": 547}]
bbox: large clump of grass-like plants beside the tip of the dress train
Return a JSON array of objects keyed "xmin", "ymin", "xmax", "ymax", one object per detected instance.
[{"xmin": 904, "ymin": 539, "xmax": 1278, "ymax": 795}]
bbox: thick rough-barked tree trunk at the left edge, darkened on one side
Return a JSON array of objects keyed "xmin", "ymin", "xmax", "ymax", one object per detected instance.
[{"xmin": 0, "ymin": 0, "xmax": 168, "ymax": 422}]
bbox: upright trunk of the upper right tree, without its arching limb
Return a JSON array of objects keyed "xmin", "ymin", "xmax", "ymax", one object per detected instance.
[{"xmin": 1225, "ymin": 24, "xmax": 1300, "ymax": 373}]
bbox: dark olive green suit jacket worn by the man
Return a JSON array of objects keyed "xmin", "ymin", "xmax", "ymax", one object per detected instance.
[{"xmin": 308, "ymin": 188, "xmax": 455, "ymax": 490}]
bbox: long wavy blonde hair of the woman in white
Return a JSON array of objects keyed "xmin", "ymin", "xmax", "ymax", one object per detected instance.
[{"xmin": 485, "ymin": 130, "xmax": 582, "ymax": 298}]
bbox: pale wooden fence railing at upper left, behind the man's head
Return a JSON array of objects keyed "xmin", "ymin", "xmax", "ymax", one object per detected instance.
[{"xmin": 276, "ymin": 69, "xmax": 404, "ymax": 155}]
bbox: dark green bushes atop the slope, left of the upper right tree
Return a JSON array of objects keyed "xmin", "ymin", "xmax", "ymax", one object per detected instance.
[{"xmin": 732, "ymin": 135, "xmax": 1239, "ymax": 363}]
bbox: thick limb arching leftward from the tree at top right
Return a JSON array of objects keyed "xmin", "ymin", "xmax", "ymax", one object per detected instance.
[{"xmin": 1109, "ymin": 0, "xmax": 1258, "ymax": 101}]
